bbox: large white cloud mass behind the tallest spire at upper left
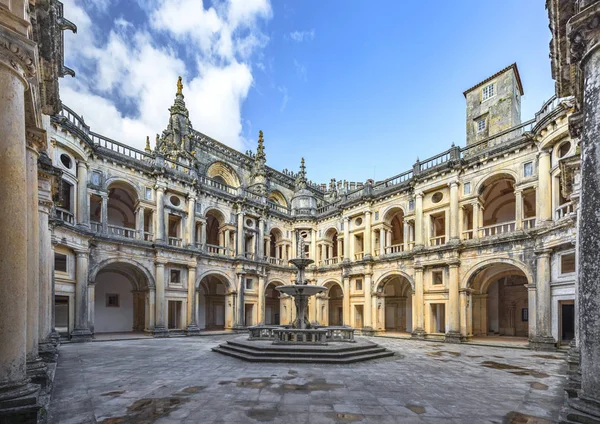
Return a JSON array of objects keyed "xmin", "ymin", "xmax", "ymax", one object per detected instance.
[{"xmin": 61, "ymin": 0, "xmax": 272, "ymax": 149}]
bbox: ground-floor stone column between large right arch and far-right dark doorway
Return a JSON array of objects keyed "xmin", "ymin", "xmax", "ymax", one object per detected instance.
[{"xmin": 530, "ymin": 250, "xmax": 556, "ymax": 350}]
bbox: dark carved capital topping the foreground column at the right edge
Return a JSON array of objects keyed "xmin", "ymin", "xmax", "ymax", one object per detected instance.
[{"xmin": 567, "ymin": 3, "xmax": 600, "ymax": 64}]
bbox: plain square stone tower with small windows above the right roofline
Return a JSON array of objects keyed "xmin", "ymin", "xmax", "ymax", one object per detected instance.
[{"xmin": 463, "ymin": 63, "xmax": 523, "ymax": 145}]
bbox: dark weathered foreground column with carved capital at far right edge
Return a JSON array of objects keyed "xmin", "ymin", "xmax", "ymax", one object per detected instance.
[{"xmin": 568, "ymin": 10, "xmax": 600, "ymax": 422}]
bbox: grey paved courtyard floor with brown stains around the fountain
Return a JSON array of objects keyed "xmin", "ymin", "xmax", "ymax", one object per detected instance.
[{"xmin": 49, "ymin": 335, "xmax": 566, "ymax": 424}]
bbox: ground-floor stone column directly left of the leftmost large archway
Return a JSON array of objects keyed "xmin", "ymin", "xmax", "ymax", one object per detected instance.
[{"xmin": 71, "ymin": 250, "xmax": 92, "ymax": 342}]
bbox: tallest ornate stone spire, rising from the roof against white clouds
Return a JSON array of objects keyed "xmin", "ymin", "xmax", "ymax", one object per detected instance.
[{"xmin": 156, "ymin": 77, "xmax": 193, "ymax": 161}]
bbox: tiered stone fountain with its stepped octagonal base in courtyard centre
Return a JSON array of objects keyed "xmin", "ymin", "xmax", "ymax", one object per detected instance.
[{"xmin": 212, "ymin": 247, "xmax": 394, "ymax": 364}]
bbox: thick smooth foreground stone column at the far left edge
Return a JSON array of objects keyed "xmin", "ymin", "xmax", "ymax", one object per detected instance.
[{"xmin": 0, "ymin": 53, "xmax": 39, "ymax": 422}]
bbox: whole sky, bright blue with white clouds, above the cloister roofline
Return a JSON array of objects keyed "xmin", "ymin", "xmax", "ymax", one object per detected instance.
[{"xmin": 62, "ymin": 0, "xmax": 554, "ymax": 182}]
